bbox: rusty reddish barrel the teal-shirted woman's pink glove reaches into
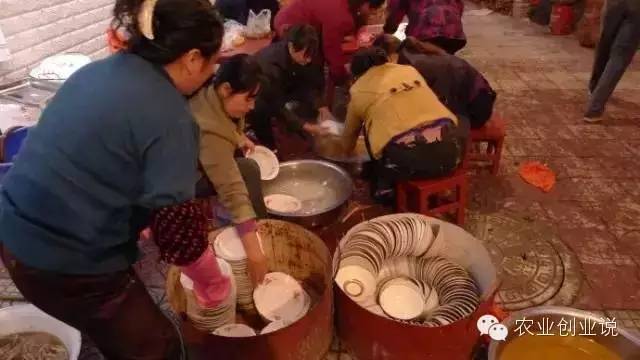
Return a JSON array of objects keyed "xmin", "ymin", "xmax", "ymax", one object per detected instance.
[{"xmin": 167, "ymin": 220, "xmax": 333, "ymax": 360}]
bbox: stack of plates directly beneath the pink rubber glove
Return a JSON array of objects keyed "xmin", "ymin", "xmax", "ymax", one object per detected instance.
[{"xmin": 180, "ymin": 258, "xmax": 236, "ymax": 332}]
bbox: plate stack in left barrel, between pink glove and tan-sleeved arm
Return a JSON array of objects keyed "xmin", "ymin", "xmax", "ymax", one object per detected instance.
[{"xmin": 213, "ymin": 227, "xmax": 262, "ymax": 312}]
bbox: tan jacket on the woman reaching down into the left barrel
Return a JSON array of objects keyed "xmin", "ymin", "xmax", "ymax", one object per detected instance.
[{"xmin": 190, "ymin": 86, "xmax": 256, "ymax": 224}]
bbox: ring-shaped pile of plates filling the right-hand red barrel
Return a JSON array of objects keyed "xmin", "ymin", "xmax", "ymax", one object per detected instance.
[{"xmin": 335, "ymin": 214, "xmax": 480, "ymax": 326}]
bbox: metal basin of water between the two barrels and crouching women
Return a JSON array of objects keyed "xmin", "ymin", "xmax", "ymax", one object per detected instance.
[{"xmin": 262, "ymin": 160, "xmax": 353, "ymax": 227}]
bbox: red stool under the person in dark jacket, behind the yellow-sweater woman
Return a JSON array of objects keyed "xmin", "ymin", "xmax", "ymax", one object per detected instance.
[{"xmin": 469, "ymin": 114, "xmax": 506, "ymax": 175}]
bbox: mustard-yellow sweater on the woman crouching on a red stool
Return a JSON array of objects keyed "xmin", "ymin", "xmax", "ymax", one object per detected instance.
[{"xmin": 343, "ymin": 63, "xmax": 458, "ymax": 159}]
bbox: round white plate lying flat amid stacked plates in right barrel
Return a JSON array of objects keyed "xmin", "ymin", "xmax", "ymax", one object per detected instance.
[{"xmin": 379, "ymin": 279, "xmax": 425, "ymax": 320}]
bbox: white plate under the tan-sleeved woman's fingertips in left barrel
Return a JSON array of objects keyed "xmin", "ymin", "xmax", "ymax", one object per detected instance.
[{"xmin": 253, "ymin": 272, "xmax": 308, "ymax": 322}]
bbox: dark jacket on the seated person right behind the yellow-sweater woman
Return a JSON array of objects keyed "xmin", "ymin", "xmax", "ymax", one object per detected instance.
[{"xmin": 398, "ymin": 49, "xmax": 496, "ymax": 128}]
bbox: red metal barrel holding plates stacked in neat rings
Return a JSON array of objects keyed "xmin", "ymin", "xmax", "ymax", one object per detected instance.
[{"xmin": 334, "ymin": 218, "xmax": 498, "ymax": 360}]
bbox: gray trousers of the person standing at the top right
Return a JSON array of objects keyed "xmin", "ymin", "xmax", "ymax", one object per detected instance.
[{"xmin": 586, "ymin": 0, "xmax": 640, "ymax": 116}]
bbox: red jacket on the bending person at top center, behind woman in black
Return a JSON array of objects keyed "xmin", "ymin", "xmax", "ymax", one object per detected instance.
[{"xmin": 274, "ymin": 0, "xmax": 356, "ymax": 84}]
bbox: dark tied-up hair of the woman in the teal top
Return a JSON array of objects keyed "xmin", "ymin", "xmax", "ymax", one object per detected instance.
[{"xmin": 113, "ymin": 0, "xmax": 224, "ymax": 65}]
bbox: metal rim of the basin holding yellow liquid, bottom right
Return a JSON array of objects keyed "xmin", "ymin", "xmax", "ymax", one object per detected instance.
[{"xmin": 489, "ymin": 306, "xmax": 640, "ymax": 360}]
